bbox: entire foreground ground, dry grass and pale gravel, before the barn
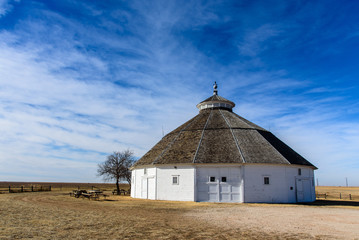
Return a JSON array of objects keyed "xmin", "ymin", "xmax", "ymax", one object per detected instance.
[{"xmin": 0, "ymin": 192, "xmax": 359, "ymax": 239}]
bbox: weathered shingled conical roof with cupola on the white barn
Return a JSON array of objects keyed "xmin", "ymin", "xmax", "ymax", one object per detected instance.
[{"xmin": 134, "ymin": 85, "xmax": 316, "ymax": 168}]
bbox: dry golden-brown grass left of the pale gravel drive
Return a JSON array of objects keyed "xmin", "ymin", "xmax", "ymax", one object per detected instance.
[{"xmin": 0, "ymin": 192, "xmax": 264, "ymax": 239}]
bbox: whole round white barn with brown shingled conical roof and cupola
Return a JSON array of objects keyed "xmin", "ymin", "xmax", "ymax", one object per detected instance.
[{"xmin": 131, "ymin": 84, "xmax": 317, "ymax": 203}]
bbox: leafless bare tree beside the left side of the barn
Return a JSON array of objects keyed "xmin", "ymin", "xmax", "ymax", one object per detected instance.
[{"xmin": 97, "ymin": 149, "xmax": 135, "ymax": 194}]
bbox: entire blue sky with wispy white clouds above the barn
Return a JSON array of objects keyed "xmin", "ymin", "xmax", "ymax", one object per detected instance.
[{"xmin": 0, "ymin": 0, "xmax": 359, "ymax": 186}]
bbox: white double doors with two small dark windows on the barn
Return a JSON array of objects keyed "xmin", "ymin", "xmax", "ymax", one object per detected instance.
[{"xmin": 196, "ymin": 167, "xmax": 240, "ymax": 202}]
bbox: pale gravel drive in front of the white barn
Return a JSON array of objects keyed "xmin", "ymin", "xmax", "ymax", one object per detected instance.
[{"xmin": 186, "ymin": 204, "xmax": 359, "ymax": 239}]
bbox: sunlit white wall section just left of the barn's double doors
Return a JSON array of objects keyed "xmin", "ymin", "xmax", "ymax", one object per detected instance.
[{"xmin": 157, "ymin": 166, "xmax": 195, "ymax": 201}]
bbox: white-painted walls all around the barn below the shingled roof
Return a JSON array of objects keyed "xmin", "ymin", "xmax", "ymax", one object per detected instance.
[{"xmin": 131, "ymin": 164, "xmax": 315, "ymax": 203}]
